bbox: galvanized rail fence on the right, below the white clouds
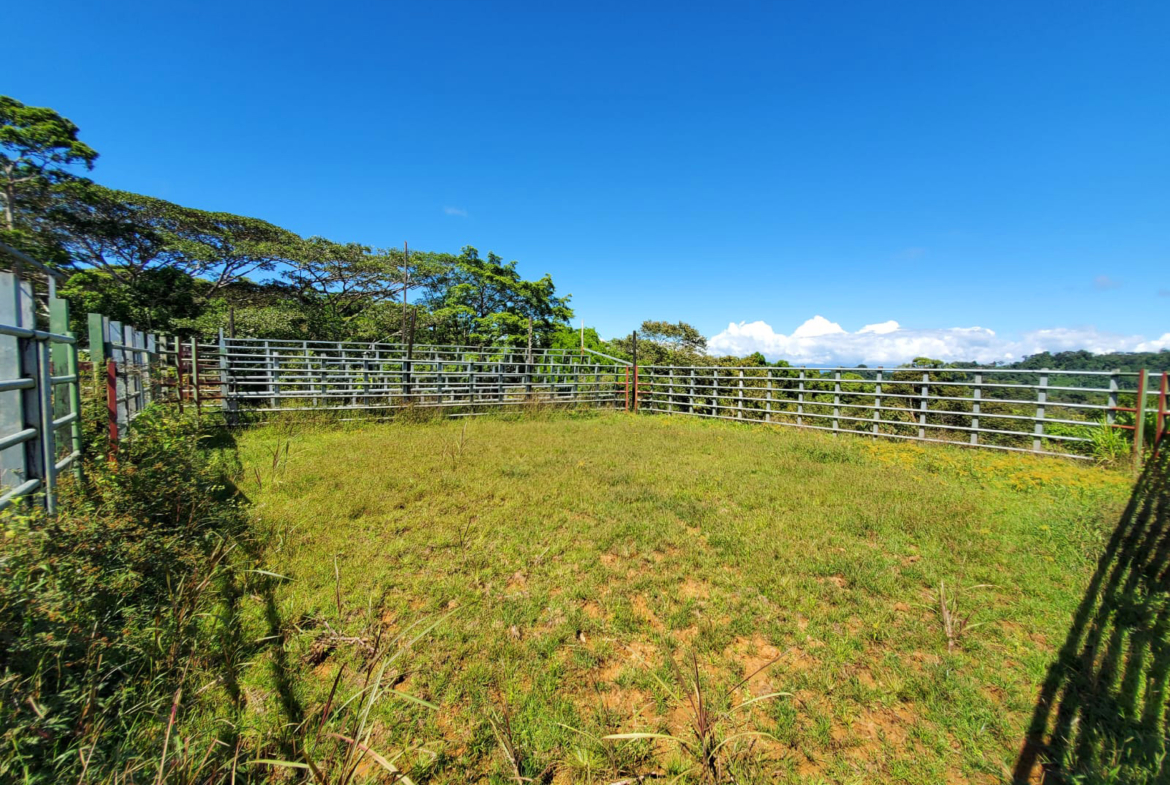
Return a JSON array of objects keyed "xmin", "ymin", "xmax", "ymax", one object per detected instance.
[{"xmin": 635, "ymin": 366, "xmax": 1170, "ymax": 457}]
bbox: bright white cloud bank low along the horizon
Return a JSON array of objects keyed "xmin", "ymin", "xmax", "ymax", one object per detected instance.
[{"xmin": 707, "ymin": 315, "xmax": 1170, "ymax": 365}]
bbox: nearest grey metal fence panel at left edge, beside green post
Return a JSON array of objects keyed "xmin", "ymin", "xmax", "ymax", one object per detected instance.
[{"xmin": 0, "ymin": 260, "xmax": 82, "ymax": 512}]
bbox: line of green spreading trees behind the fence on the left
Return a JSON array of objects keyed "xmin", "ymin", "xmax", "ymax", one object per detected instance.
[{"xmin": 0, "ymin": 96, "xmax": 573, "ymax": 346}]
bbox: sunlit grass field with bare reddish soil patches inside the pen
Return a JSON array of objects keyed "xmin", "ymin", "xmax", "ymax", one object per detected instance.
[{"xmin": 215, "ymin": 414, "xmax": 1131, "ymax": 784}]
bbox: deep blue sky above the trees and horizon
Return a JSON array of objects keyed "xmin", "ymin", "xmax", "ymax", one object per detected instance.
[{"xmin": 11, "ymin": 0, "xmax": 1170, "ymax": 361}]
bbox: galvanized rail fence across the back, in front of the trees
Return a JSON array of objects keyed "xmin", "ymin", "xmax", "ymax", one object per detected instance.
[{"xmin": 200, "ymin": 335, "xmax": 629, "ymax": 419}]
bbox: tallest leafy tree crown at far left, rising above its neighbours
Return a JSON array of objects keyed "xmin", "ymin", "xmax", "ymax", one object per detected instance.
[{"xmin": 0, "ymin": 96, "xmax": 97, "ymax": 232}]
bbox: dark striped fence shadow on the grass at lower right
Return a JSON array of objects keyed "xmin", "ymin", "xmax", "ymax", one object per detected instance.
[{"xmin": 1012, "ymin": 449, "xmax": 1170, "ymax": 784}]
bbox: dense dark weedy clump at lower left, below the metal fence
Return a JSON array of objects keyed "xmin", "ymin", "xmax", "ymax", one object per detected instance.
[{"xmin": 0, "ymin": 408, "xmax": 246, "ymax": 783}]
